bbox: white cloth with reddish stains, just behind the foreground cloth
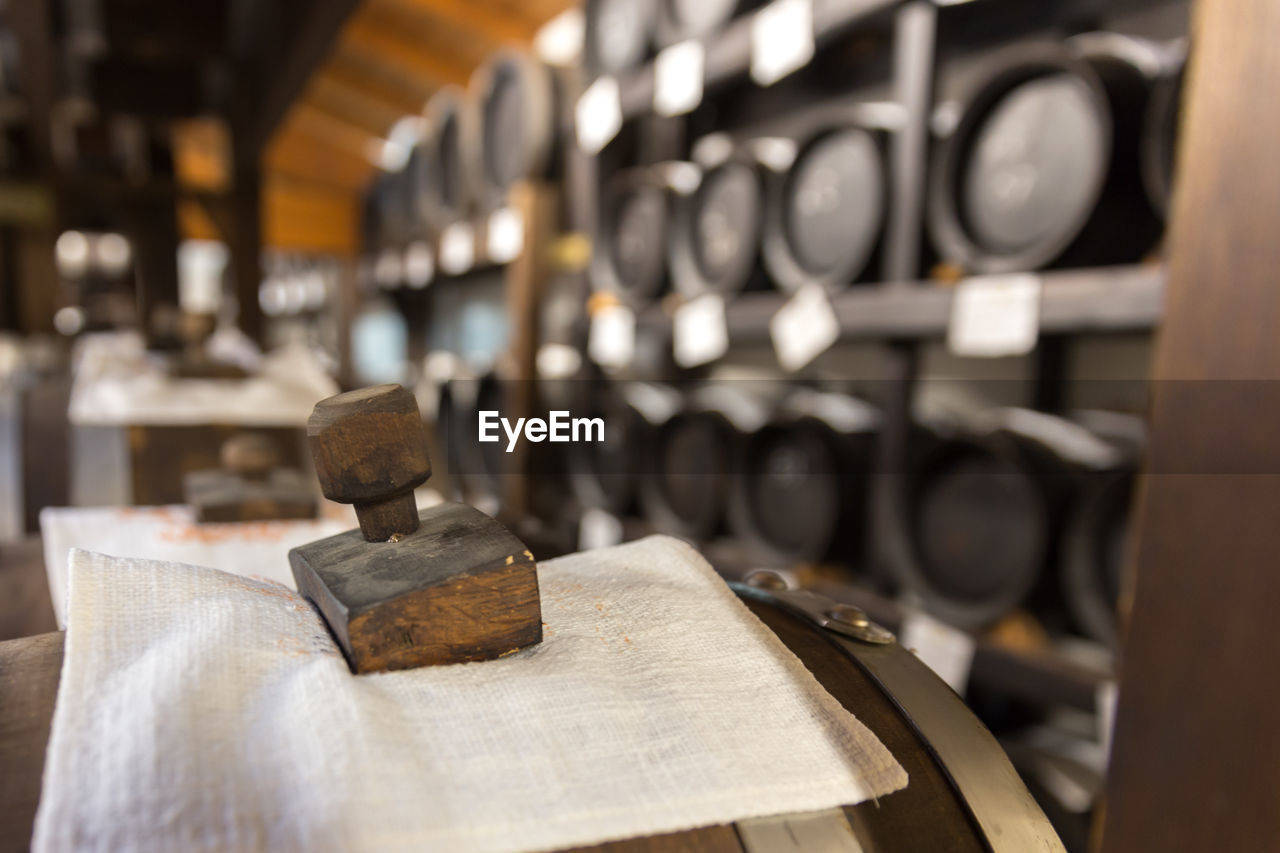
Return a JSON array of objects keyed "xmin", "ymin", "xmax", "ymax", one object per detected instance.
[{"xmin": 40, "ymin": 505, "xmax": 355, "ymax": 628}]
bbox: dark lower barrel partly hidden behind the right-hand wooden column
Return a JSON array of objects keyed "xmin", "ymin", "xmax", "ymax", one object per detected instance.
[{"xmin": 1059, "ymin": 471, "xmax": 1133, "ymax": 646}]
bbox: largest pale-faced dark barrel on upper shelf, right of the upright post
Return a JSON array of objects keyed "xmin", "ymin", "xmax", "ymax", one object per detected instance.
[{"xmin": 929, "ymin": 37, "xmax": 1160, "ymax": 273}]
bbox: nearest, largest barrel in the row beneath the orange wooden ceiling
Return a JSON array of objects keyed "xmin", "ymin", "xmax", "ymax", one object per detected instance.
[{"xmin": 470, "ymin": 51, "xmax": 561, "ymax": 205}]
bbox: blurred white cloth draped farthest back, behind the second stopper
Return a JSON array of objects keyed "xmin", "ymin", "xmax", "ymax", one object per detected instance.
[{"xmin": 68, "ymin": 346, "xmax": 338, "ymax": 427}]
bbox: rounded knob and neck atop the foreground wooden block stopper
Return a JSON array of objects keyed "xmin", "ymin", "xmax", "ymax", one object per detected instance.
[{"xmin": 307, "ymin": 384, "xmax": 431, "ymax": 542}]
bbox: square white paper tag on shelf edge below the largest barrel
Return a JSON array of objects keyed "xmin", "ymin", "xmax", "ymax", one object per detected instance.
[{"xmin": 947, "ymin": 273, "xmax": 1041, "ymax": 359}]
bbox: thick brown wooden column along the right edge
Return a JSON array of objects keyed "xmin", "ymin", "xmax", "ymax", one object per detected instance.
[{"xmin": 1101, "ymin": 0, "xmax": 1280, "ymax": 853}]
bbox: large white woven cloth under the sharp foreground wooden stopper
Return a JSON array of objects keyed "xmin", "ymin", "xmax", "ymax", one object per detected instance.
[{"xmin": 33, "ymin": 537, "xmax": 906, "ymax": 853}]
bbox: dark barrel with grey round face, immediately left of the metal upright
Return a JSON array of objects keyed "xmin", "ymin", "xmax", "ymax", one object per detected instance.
[{"xmin": 763, "ymin": 127, "xmax": 888, "ymax": 291}]
